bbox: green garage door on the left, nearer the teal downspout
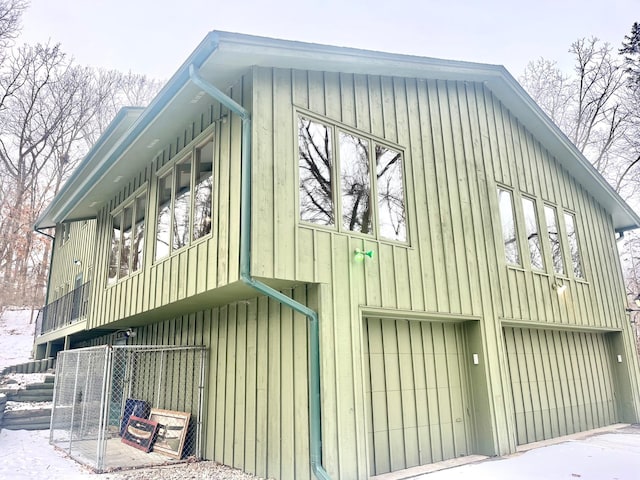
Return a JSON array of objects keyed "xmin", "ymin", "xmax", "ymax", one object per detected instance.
[{"xmin": 365, "ymin": 318, "xmax": 471, "ymax": 475}]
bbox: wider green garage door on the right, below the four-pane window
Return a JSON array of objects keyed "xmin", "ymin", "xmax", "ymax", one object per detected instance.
[{"xmin": 504, "ymin": 328, "xmax": 617, "ymax": 445}]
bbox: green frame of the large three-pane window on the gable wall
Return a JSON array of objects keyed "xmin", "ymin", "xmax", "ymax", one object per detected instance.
[{"xmin": 293, "ymin": 107, "xmax": 411, "ymax": 246}]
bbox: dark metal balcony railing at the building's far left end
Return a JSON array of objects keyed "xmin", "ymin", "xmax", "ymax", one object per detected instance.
[{"xmin": 36, "ymin": 282, "xmax": 91, "ymax": 335}]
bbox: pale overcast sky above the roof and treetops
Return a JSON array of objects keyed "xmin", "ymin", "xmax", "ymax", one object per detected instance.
[{"xmin": 21, "ymin": 0, "xmax": 640, "ymax": 79}]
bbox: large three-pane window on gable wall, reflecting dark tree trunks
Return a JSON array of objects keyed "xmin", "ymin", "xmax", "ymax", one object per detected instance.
[{"xmin": 298, "ymin": 115, "xmax": 407, "ymax": 242}]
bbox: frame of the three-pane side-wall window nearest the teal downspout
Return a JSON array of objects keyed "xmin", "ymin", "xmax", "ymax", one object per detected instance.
[{"xmin": 150, "ymin": 129, "xmax": 218, "ymax": 264}]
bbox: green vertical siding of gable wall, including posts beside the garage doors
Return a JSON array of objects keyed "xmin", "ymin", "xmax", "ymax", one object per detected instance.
[{"xmin": 251, "ymin": 67, "xmax": 636, "ymax": 478}]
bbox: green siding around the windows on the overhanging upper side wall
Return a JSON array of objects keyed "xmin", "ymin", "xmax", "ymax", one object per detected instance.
[{"xmin": 90, "ymin": 79, "xmax": 251, "ymax": 328}]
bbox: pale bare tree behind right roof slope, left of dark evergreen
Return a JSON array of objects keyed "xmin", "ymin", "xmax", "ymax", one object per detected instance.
[{"xmin": 520, "ymin": 38, "xmax": 633, "ymax": 189}]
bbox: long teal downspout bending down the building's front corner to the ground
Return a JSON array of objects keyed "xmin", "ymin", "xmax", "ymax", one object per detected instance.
[{"xmin": 189, "ymin": 65, "xmax": 331, "ymax": 480}]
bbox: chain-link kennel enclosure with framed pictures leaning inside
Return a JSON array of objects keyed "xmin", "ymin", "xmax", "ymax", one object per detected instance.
[{"xmin": 50, "ymin": 345, "xmax": 206, "ymax": 472}]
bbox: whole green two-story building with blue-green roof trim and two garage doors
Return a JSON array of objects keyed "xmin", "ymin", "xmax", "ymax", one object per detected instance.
[{"xmin": 36, "ymin": 32, "xmax": 640, "ymax": 480}]
